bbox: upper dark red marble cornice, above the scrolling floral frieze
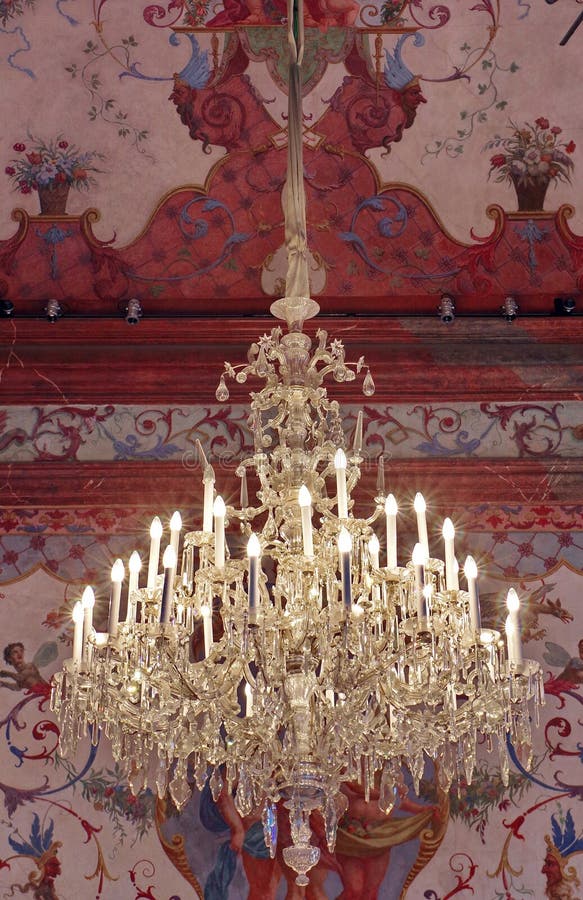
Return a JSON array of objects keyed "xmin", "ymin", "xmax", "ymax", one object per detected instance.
[{"xmin": 0, "ymin": 316, "xmax": 583, "ymax": 405}]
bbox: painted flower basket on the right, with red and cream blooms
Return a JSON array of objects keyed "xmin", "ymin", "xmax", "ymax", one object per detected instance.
[{"xmin": 484, "ymin": 116, "xmax": 575, "ymax": 211}]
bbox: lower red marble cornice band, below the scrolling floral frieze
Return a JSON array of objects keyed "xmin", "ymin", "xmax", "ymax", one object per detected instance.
[{"xmin": 0, "ymin": 459, "xmax": 583, "ymax": 522}]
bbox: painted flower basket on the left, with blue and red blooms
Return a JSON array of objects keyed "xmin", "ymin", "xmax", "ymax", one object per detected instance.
[{"xmin": 5, "ymin": 135, "xmax": 104, "ymax": 216}]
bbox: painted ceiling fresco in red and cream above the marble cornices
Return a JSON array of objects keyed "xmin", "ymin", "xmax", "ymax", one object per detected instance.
[{"xmin": 0, "ymin": 0, "xmax": 583, "ymax": 312}]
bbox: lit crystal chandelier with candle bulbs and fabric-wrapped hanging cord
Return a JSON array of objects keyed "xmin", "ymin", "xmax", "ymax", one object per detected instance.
[{"xmin": 51, "ymin": 1, "xmax": 543, "ymax": 885}]
